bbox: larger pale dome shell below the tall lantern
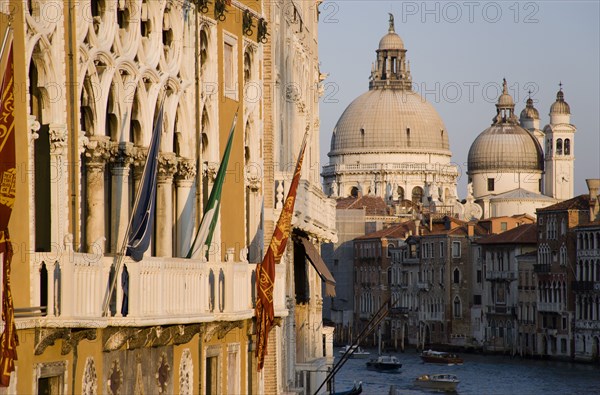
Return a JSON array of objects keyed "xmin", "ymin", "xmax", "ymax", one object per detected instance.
[{"xmin": 329, "ymin": 89, "xmax": 450, "ymax": 156}]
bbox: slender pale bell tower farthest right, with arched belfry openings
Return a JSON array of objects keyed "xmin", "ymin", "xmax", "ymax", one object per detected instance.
[{"xmin": 544, "ymin": 83, "xmax": 577, "ymax": 200}]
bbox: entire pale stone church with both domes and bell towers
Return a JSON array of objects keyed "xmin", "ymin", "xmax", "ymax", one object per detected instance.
[{"xmin": 322, "ymin": 14, "xmax": 576, "ymax": 220}]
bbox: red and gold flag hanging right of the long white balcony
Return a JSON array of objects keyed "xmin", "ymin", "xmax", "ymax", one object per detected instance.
[{"xmin": 255, "ymin": 132, "xmax": 308, "ymax": 371}]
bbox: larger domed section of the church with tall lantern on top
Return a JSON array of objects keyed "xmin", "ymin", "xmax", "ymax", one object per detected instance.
[{"xmin": 322, "ymin": 14, "xmax": 458, "ymax": 212}]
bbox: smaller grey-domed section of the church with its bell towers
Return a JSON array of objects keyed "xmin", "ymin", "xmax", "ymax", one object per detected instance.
[{"xmin": 468, "ymin": 80, "xmax": 576, "ymax": 218}]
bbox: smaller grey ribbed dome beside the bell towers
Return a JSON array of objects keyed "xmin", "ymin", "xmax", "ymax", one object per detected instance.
[{"xmin": 468, "ymin": 123, "xmax": 544, "ymax": 174}]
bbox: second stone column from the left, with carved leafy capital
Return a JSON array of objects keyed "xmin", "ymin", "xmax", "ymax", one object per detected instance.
[{"xmin": 85, "ymin": 136, "xmax": 110, "ymax": 255}]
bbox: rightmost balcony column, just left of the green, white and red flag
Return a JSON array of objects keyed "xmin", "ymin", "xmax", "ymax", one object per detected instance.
[{"xmin": 175, "ymin": 158, "xmax": 196, "ymax": 257}]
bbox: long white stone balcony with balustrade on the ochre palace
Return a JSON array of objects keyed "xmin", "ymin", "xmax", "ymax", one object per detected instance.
[{"xmin": 22, "ymin": 253, "xmax": 287, "ymax": 327}]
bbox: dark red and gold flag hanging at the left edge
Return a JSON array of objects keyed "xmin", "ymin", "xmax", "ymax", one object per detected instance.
[{"xmin": 0, "ymin": 28, "xmax": 19, "ymax": 387}]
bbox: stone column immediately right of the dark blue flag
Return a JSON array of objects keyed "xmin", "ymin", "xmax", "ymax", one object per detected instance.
[{"xmin": 156, "ymin": 152, "xmax": 177, "ymax": 256}]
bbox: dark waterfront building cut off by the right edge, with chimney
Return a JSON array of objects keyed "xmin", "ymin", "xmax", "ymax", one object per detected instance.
[{"xmin": 573, "ymin": 180, "xmax": 600, "ymax": 361}]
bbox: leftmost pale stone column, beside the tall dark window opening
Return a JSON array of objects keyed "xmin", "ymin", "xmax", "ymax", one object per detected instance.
[{"xmin": 49, "ymin": 124, "xmax": 69, "ymax": 250}]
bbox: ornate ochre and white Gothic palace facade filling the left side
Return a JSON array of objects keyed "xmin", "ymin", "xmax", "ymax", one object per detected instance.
[{"xmin": 0, "ymin": 0, "xmax": 335, "ymax": 394}]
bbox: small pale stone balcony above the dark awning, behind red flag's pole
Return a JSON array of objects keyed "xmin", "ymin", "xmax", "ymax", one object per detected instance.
[{"xmin": 273, "ymin": 172, "xmax": 337, "ymax": 242}]
